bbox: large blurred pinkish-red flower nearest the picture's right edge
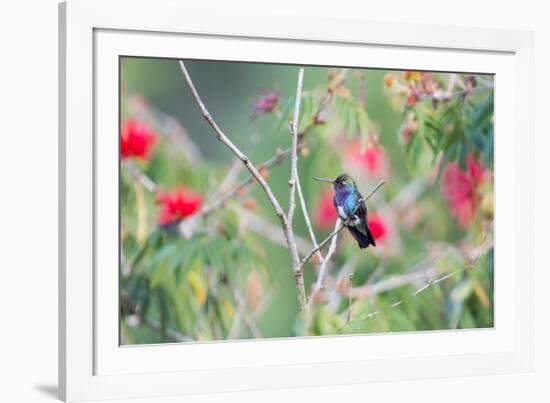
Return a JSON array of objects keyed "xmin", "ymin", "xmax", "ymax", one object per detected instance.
[{"xmin": 442, "ymin": 155, "xmax": 490, "ymax": 227}]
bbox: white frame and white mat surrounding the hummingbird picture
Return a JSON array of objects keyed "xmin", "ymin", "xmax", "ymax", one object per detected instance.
[{"xmin": 59, "ymin": 0, "xmax": 534, "ymax": 401}]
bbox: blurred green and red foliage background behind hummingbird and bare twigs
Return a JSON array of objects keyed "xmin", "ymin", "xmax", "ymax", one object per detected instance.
[{"xmin": 120, "ymin": 58, "xmax": 494, "ymax": 344}]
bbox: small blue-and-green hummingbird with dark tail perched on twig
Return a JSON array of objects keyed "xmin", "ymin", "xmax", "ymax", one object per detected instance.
[{"xmin": 314, "ymin": 174, "xmax": 376, "ymax": 249}]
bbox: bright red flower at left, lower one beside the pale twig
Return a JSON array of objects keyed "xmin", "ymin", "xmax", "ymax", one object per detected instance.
[{"xmin": 156, "ymin": 187, "xmax": 202, "ymax": 226}]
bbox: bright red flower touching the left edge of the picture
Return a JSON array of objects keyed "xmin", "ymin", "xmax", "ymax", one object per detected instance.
[{"xmin": 120, "ymin": 119, "xmax": 157, "ymax": 159}]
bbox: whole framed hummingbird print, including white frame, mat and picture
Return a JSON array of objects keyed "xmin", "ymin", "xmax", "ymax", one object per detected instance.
[{"xmin": 59, "ymin": 0, "xmax": 534, "ymax": 401}]
